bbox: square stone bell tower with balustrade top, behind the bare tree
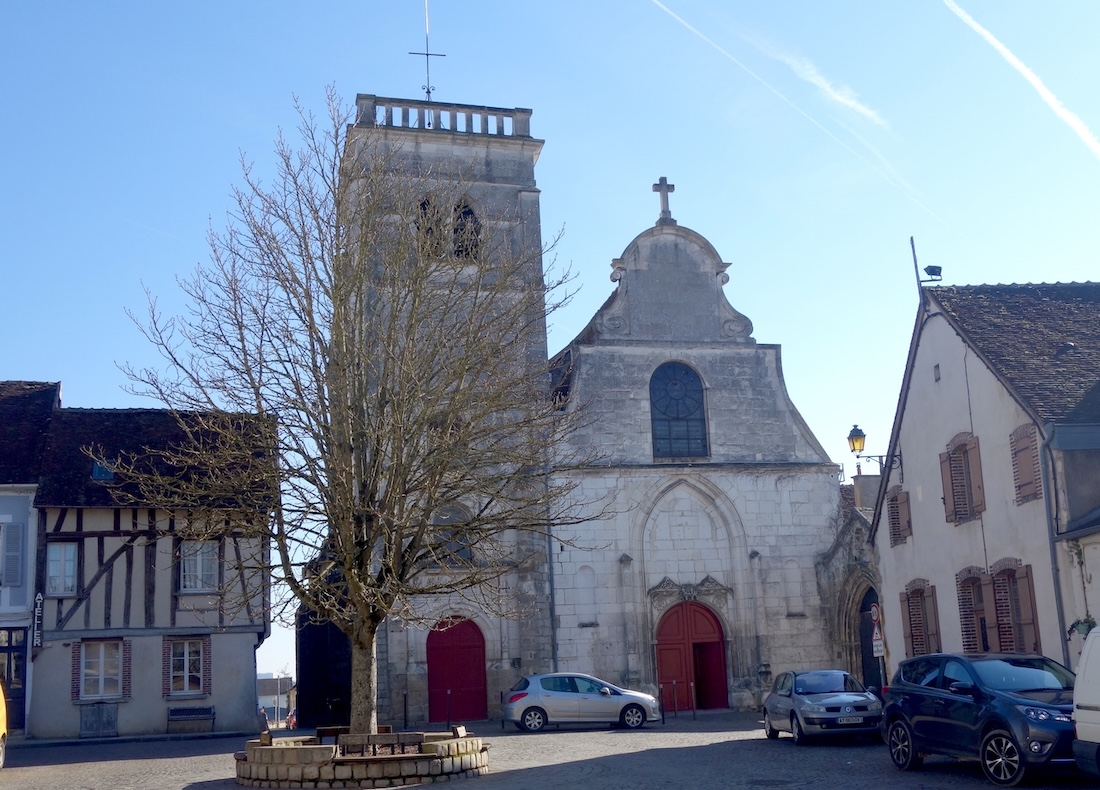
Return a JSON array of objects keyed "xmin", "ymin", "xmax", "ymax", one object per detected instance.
[{"xmin": 298, "ymin": 95, "xmax": 553, "ymax": 725}]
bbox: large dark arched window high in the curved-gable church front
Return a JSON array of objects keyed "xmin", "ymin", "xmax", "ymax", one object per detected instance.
[{"xmin": 649, "ymin": 362, "xmax": 708, "ymax": 458}]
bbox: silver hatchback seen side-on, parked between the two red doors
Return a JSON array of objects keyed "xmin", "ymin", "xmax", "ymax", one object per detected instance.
[{"xmin": 501, "ymin": 672, "xmax": 661, "ymax": 733}]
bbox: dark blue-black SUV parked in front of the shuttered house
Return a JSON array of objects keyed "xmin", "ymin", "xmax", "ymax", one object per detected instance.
[{"xmin": 882, "ymin": 652, "xmax": 1074, "ymax": 787}]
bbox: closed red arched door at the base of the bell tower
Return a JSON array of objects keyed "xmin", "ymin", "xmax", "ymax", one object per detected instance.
[{"xmin": 428, "ymin": 617, "xmax": 488, "ymax": 722}]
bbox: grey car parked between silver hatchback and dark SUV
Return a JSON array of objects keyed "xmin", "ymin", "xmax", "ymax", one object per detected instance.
[{"xmin": 763, "ymin": 669, "xmax": 882, "ymax": 744}]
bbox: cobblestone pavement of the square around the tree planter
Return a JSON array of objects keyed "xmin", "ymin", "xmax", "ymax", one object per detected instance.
[{"xmin": 0, "ymin": 713, "xmax": 1097, "ymax": 790}]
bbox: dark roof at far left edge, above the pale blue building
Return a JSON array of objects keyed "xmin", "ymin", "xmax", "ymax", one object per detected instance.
[{"xmin": 0, "ymin": 381, "xmax": 62, "ymax": 484}]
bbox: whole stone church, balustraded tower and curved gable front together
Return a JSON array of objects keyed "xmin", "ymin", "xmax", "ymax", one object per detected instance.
[{"xmin": 298, "ymin": 96, "xmax": 873, "ymax": 726}]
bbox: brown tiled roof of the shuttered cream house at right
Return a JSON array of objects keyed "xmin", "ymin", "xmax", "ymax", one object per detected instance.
[{"xmin": 927, "ymin": 283, "xmax": 1100, "ymax": 424}]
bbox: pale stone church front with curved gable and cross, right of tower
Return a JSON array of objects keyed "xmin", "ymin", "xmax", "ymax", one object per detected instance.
[{"xmin": 551, "ymin": 178, "xmax": 839, "ymax": 710}]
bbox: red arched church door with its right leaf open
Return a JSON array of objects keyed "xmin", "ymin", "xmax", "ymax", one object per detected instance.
[{"xmin": 657, "ymin": 601, "xmax": 729, "ymax": 711}]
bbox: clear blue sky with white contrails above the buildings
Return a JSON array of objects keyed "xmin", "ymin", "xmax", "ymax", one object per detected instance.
[{"xmin": 0, "ymin": 0, "xmax": 1100, "ymax": 672}]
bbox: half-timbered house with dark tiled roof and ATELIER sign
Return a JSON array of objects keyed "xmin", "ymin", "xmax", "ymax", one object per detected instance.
[{"xmin": 0, "ymin": 389, "xmax": 270, "ymax": 738}]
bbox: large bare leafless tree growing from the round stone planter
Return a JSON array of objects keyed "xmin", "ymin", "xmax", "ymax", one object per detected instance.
[{"xmin": 127, "ymin": 90, "xmax": 591, "ymax": 732}]
